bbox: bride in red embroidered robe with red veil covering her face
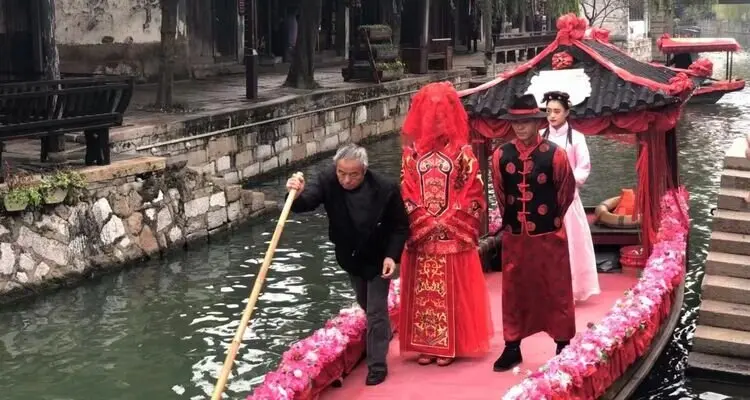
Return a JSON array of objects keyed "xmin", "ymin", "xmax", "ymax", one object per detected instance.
[{"xmin": 399, "ymin": 83, "xmax": 494, "ymax": 366}]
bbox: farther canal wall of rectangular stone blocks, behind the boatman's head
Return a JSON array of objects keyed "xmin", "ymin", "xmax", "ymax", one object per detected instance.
[{"xmin": 117, "ymin": 70, "xmax": 471, "ymax": 183}]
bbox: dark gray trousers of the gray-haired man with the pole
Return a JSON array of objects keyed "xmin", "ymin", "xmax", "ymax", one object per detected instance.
[{"xmin": 349, "ymin": 275, "xmax": 393, "ymax": 371}]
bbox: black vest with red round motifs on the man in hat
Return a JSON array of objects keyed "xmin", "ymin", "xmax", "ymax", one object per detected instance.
[{"xmin": 498, "ymin": 140, "xmax": 562, "ymax": 236}]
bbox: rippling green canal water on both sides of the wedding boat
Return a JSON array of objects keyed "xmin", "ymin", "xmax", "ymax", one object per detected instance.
[{"xmin": 0, "ymin": 54, "xmax": 750, "ymax": 400}]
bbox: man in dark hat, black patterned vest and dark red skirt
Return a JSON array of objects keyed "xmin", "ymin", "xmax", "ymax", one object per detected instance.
[{"xmin": 491, "ymin": 95, "xmax": 576, "ymax": 371}]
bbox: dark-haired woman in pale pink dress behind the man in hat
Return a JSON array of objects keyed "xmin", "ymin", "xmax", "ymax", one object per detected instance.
[{"xmin": 542, "ymin": 92, "xmax": 601, "ymax": 302}]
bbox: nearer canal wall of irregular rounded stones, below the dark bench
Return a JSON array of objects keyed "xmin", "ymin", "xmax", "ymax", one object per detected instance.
[{"xmin": 0, "ymin": 157, "xmax": 277, "ymax": 302}]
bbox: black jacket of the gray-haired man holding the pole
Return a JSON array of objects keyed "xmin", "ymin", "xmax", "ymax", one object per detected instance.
[{"xmin": 292, "ymin": 166, "xmax": 409, "ymax": 280}]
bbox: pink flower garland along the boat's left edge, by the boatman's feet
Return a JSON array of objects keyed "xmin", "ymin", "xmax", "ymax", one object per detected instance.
[{"xmin": 247, "ymin": 279, "xmax": 401, "ymax": 400}]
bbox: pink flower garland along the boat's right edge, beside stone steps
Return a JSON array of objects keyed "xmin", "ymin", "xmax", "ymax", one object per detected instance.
[{"xmin": 503, "ymin": 188, "xmax": 689, "ymax": 400}]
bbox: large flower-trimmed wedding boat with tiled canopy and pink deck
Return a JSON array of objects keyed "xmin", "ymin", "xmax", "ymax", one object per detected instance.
[{"xmin": 248, "ymin": 14, "xmax": 694, "ymax": 400}]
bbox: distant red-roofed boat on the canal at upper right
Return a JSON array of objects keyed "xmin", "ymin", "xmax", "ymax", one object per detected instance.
[{"xmin": 657, "ymin": 35, "xmax": 745, "ymax": 104}]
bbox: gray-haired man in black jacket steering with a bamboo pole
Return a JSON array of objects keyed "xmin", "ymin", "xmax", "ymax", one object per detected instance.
[{"xmin": 286, "ymin": 144, "xmax": 409, "ymax": 385}]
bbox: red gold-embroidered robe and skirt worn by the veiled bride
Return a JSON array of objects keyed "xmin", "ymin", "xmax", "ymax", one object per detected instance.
[{"xmin": 399, "ymin": 145, "xmax": 493, "ymax": 357}]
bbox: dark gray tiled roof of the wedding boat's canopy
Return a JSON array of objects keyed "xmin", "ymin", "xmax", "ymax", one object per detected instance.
[{"xmin": 464, "ymin": 40, "xmax": 704, "ymax": 118}]
